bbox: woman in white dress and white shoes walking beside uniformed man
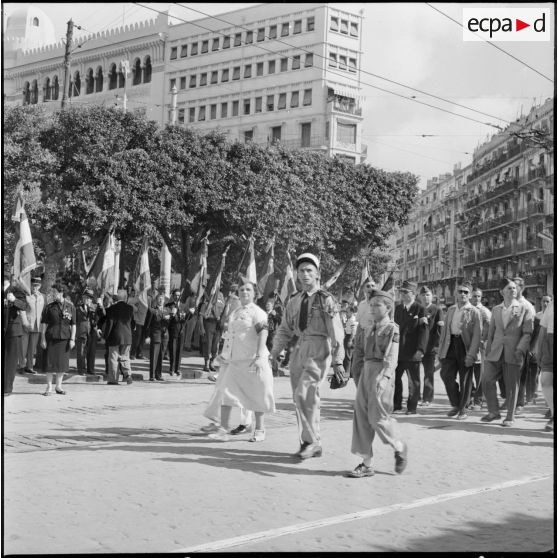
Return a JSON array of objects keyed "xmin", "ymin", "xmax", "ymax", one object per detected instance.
[{"xmin": 204, "ymin": 282, "xmax": 275, "ymax": 442}]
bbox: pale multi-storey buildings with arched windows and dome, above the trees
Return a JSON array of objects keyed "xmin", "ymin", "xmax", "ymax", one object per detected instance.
[{"xmin": 4, "ymin": 3, "xmax": 366, "ymax": 162}]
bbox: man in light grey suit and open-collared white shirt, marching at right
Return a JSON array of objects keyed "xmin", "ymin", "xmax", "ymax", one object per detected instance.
[{"xmin": 481, "ymin": 278, "xmax": 535, "ymax": 426}]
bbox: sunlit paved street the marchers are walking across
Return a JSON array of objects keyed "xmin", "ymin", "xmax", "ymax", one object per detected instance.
[{"xmin": 3, "ymin": 353, "xmax": 555, "ymax": 554}]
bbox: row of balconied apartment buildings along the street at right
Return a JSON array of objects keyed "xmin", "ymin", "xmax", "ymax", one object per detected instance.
[{"xmin": 396, "ymin": 99, "xmax": 555, "ymax": 312}]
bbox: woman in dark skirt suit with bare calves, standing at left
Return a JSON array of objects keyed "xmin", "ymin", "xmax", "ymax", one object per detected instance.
[{"xmin": 41, "ymin": 284, "xmax": 76, "ymax": 395}]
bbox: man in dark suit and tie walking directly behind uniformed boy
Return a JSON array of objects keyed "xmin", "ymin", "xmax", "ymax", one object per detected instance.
[{"xmin": 393, "ymin": 281, "xmax": 428, "ymax": 415}]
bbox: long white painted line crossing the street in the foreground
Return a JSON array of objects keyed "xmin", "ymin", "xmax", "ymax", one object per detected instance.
[{"xmin": 177, "ymin": 475, "xmax": 552, "ymax": 553}]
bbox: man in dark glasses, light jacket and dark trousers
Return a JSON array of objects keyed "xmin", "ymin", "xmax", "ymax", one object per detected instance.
[{"xmin": 439, "ymin": 281, "xmax": 481, "ymax": 420}]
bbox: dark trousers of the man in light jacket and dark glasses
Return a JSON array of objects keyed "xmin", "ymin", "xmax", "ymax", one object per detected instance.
[{"xmin": 440, "ymin": 335, "xmax": 473, "ymax": 413}]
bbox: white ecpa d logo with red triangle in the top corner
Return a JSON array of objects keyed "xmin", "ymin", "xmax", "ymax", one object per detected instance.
[{"xmin": 463, "ymin": 8, "xmax": 553, "ymax": 42}]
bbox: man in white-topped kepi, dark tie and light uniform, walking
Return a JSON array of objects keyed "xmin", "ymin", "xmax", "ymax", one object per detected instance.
[{"xmin": 271, "ymin": 253, "xmax": 345, "ymax": 459}]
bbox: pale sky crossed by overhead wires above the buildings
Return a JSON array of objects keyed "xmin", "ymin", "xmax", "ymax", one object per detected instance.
[{"xmin": 4, "ymin": 2, "xmax": 555, "ymax": 187}]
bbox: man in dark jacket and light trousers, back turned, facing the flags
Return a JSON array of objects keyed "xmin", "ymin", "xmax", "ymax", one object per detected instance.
[{"xmin": 105, "ymin": 289, "xmax": 135, "ymax": 385}]
